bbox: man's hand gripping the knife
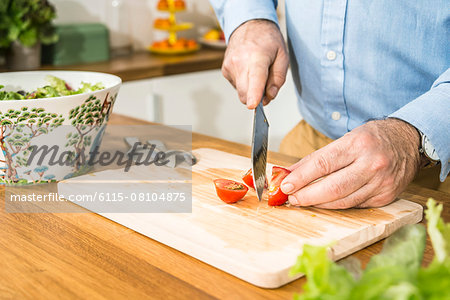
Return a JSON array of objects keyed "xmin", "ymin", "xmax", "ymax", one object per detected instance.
[{"xmin": 222, "ymin": 20, "xmax": 289, "ymax": 109}]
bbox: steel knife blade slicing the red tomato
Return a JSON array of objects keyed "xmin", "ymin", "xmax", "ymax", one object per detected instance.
[{"xmin": 252, "ymin": 96, "xmax": 269, "ymax": 201}]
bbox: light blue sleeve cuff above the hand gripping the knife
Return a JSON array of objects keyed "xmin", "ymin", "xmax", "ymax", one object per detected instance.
[{"xmin": 210, "ymin": 0, "xmax": 278, "ymax": 43}]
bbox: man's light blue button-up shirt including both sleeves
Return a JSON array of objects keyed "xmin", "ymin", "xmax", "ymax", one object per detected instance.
[{"xmin": 211, "ymin": 0, "xmax": 450, "ymax": 181}]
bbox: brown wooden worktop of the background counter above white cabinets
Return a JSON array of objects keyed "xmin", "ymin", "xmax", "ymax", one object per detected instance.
[{"xmin": 0, "ymin": 47, "xmax": 225, "ymax": 81}]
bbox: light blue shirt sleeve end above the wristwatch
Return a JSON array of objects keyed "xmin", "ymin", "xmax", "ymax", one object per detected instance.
[{"xmin": 390, "ymin": 68, "xmax": 450, "ymax": 181}]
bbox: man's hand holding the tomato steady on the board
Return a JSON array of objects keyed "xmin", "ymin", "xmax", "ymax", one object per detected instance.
[{"xmin": 281, "ymin": 119, "xmax": 421, "ymax": 209}]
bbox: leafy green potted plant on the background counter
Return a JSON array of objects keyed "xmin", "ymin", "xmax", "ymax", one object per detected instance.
[{"xmin": 0, "ymin": 0, "xmax": 58, "ymax": 70}]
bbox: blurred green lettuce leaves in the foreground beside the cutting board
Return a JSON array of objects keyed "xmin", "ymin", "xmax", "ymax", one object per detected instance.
[{"xmin": 290, "ymin": 199, "xmax": 450, "ymax": 300}]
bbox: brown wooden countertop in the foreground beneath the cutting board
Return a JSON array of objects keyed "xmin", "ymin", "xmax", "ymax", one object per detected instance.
[{"xmin": 0, "ymin": 115, "xmax": 450, "ymax": 299}]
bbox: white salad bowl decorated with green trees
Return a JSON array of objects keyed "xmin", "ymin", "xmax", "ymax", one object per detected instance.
[{"xmin": 0, "ymin": 71, "xmax": 122, "ymax": 184}]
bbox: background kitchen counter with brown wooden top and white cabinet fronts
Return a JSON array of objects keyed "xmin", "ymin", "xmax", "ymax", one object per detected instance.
[{"xmin": 0, "ymin": 47, "xmax": 301, "ymax": 151}]
